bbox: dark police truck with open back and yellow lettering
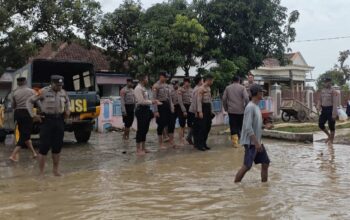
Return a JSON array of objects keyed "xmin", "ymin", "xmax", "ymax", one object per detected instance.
[{"xmin": 0, "ymin": 59, "xmax": 100, "ymax": 143}]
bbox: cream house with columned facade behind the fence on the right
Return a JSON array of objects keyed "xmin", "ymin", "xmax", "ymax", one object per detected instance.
[{"xmin": 251, "ymin": 52, "xmax": 314, "ymax": 93}]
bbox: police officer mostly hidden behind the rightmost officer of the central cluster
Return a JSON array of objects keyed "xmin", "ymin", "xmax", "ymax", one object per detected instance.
[{"xmin": 186, "ymin": 75, "xmax": 203, "ymax": 148}]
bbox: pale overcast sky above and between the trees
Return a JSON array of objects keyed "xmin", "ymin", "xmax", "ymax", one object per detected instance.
[{"xmin": 100, "ymin": 0, "xmax": 350, "ymax": 77}]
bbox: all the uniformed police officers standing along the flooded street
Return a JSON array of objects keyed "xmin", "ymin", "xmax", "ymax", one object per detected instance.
[{"xmin": 10, "ymin": 72, "xmax": 339, "ymax": 176}]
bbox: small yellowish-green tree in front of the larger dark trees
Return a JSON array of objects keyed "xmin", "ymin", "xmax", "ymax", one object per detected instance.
[{"xmin": 172, "ymin": 15, "xmax": 208, "ymax": 77}]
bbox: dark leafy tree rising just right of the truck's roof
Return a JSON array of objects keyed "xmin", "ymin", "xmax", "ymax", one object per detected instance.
[{"xmin": 99, "ymin": 0, "xmax": 142, "ymax": 72}]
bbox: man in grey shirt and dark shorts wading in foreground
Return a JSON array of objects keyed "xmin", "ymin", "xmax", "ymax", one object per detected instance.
[{"xmin": 235, "ymin": 84, "xmax": 272, "ymax": 183}]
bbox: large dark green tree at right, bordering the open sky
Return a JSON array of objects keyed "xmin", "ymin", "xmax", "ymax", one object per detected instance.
[{"xmin": 193, "ymin": 0, "xmax": 299, "ymax": 75}]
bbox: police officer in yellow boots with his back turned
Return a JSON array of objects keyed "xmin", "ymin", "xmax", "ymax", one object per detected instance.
[{"xmin": 222, "ymin": 76, "xmax": 249, "ymax": 147}]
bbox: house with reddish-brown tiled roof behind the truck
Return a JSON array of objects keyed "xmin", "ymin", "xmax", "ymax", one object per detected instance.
[{"xmin": 30, "ymin": 42, "xmax": 129, "ymax": 97}]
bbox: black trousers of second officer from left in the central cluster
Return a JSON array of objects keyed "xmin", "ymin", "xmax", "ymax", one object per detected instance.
[{"xmin": 135, "ymin": 106, "xmax": 153, "ymax": 143}]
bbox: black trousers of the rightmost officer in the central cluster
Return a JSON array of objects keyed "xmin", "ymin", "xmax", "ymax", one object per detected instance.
[{"xmin": 193, "ymin": 103, "xmax": 212, "ymax": 148}]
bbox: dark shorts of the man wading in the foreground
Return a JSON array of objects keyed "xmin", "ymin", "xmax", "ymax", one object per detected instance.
[{"xmin": 244, "ymin": 145, "xmax": 270, "ymax": 169}]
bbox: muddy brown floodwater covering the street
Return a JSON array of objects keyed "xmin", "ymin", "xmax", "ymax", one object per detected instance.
[{"xmin": 0, "ymin": 129, "xmax": 350, "ymax": 220}]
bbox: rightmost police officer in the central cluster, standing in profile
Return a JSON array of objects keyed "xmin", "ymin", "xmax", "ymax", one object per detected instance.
[{"xmin": 193, "ymin": 74, "xmax": 215, "ymax": 151}]
